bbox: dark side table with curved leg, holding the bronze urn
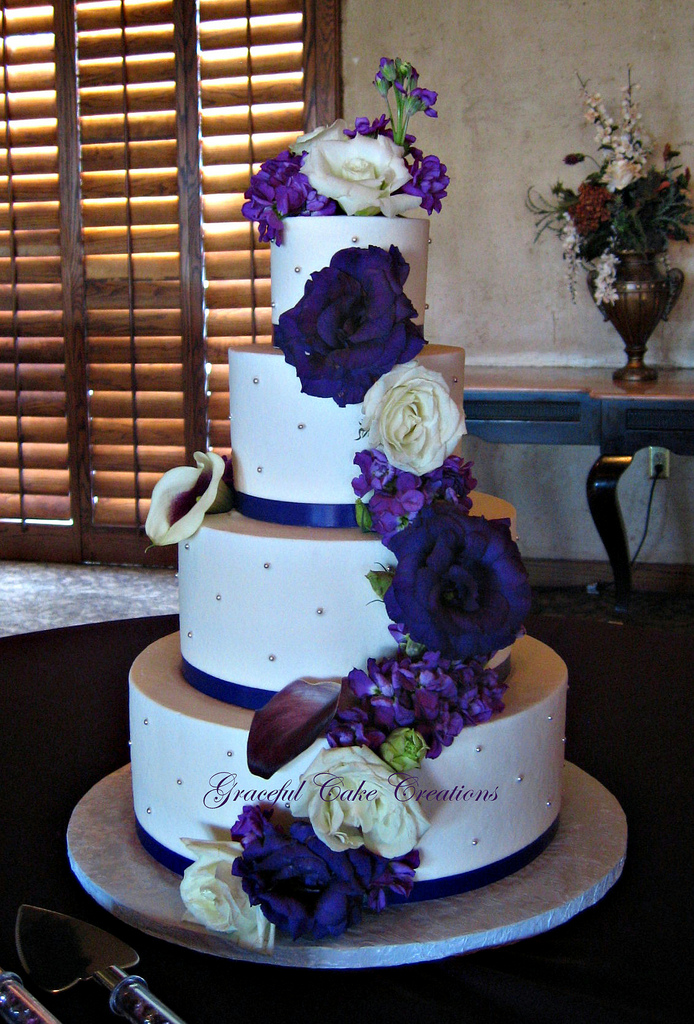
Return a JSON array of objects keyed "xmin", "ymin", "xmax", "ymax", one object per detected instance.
[{"xmin": 465, "ymin": 366, "xmax": 694, "ymax": 613}]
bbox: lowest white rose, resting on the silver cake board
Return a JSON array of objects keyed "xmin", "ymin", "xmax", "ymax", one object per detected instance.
[{"xmin": 180, "ymin": 839, "xmax": 274, "ymax": 952}]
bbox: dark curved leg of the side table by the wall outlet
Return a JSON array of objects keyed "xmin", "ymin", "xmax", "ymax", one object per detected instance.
[{"xmin": 585, "ymin": 455, "xmax": 633, "ymax": 613}]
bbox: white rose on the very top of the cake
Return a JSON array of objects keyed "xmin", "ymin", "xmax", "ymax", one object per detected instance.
[{"xmin": 301, "ymin": 135, "xmax": 422, "ymax": 217}]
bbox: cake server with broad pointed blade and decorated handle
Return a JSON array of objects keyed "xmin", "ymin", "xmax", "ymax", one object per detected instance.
[{"xmin": 15, "ymin": 903, "xmax": 189, "ymax": 1024}]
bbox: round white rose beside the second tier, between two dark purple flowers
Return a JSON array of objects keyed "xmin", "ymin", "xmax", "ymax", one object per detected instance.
[{"xmin": 361, "ymin": 361, "xmax": 466, "ymax": 476}]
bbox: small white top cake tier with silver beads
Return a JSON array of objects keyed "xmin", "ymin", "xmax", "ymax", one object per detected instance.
[{"xmin": 270, "ymin": 217, "xmax": 429, "ymax": 324}]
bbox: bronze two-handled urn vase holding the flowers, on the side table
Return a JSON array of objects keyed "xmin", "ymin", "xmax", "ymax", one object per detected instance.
[{"xmin": 588, "ymin": 252, "xmax": 685, "ymax": 383}]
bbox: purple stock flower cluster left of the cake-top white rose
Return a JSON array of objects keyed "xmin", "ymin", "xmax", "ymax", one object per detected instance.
[{"xmin": 242, "ymin": 150, "xmax": 337, "ymax": 245}]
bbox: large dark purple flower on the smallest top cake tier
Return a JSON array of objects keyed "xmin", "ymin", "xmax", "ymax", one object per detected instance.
[{"xmin": 274, "ymin": 246, "xmax": 426, "ymax": 406}]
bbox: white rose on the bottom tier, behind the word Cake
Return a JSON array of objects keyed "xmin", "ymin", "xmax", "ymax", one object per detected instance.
[{"xmin": 294, "ymin": 746, "xmax": 429, "ymax": 857}]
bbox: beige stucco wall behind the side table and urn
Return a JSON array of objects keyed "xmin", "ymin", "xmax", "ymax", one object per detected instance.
[{"xmin": 343, "ymin": 0, "xmax": 694, "ymax": 562}]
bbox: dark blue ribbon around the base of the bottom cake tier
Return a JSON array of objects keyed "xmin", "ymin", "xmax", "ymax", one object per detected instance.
[{"xmin": 135, "ymin": 815, "xmax": 559, "ymax": 903}]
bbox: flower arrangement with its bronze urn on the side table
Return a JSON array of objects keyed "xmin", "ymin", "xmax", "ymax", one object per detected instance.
[{"xmin": 526, "ymin": 71, "xmax": 694, "ymax": 382}]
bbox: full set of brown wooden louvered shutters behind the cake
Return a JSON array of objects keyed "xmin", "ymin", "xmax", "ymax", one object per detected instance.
[{"xmin": 0, "ymin": 0, "xmax": 339, "ymax": 562}]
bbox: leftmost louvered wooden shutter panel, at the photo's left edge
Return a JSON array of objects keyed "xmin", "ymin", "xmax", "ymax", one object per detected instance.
[{"xmin": 0, "ymin": 0, "xmax": 74, "ymax": 558}]
